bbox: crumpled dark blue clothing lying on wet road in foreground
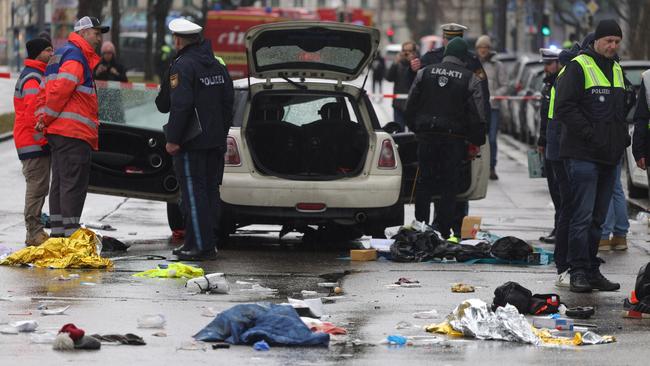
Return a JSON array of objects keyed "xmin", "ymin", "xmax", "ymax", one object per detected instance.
[{"xmin": 194, "ymin": 303, "xmax": 330, "ymax": 347}]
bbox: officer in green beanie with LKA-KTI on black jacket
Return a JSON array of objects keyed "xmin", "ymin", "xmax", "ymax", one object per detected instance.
[{"xmin": 405, "ymin": 37, "xmax": 486, "ymax": 238}]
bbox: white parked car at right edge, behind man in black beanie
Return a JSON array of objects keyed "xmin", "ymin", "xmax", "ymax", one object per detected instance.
[{"xmin": 621, "ymin": 60, "xmax": 650, "ymax": 198}]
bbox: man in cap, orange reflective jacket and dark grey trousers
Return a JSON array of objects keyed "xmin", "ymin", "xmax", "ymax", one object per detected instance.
[{"xmin": 37, "ymin": 17, "xmax": 109, "ymax": 237}]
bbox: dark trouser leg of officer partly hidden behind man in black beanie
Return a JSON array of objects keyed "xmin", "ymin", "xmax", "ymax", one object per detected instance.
[{"xmin": 546, "ymin": 160, "xmax": 571, "ymax": 274}]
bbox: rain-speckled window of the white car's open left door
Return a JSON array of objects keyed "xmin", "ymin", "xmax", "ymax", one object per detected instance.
[{"xmin": 97, "ymin": 81, "xmax": 168, "ymax": 131}]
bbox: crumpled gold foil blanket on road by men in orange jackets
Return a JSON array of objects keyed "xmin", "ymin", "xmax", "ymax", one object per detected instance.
[{"xmin": 0, "ymin": 228, "xmax": 113, "ymax": 268}]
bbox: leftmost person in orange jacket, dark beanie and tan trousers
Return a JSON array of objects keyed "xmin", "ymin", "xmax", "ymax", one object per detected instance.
[{"xmin": 13, "ymin": 38, "xmax": 54, "ymax": 245}]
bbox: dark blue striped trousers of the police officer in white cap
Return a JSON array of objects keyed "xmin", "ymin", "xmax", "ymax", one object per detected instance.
[{"xmin": 174, "ymin": 149, "xmax": 224, "ymax": 252}]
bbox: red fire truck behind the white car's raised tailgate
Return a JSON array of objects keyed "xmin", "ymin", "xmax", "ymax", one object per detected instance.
[{"xmin": 204, "ymin": 7, "xmax": 372, "ymax": 79}]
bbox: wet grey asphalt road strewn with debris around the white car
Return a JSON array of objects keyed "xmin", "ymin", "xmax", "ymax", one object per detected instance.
[{"xmin": 0, "ymin": 136, "xmax": 650, "ymax": 366}]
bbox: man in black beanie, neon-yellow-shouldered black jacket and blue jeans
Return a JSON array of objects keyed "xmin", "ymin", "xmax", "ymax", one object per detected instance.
[{"xmin": 555, "ymin": 20, "xmax": 630, "ymax": 292}]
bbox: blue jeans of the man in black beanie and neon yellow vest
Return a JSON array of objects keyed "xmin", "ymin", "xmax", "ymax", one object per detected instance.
[{"xmin": 565, "ymin": 159, "xmax": 616, "ymax": 273}]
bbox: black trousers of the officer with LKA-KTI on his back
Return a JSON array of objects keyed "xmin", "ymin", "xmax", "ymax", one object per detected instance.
[{"xmin": 415, "ymin": 135, "xmax": 466, "ymax": 238}]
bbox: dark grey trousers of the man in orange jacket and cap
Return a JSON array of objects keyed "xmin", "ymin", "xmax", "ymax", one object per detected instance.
[{"xmin": 47, "ymin": 135, "xmax": 91, "ymax": 237}]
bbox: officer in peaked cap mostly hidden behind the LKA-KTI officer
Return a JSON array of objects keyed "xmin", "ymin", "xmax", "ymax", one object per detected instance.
[{"xmin": 411, "ymin": 23, "xmax": 491, "ymax": 235}]
